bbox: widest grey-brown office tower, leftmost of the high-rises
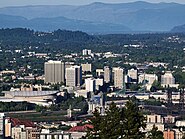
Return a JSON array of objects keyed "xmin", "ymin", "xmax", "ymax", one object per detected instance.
[{"xmin": 44, "ymin": 60, "xmax": 65, "ymax": 84}]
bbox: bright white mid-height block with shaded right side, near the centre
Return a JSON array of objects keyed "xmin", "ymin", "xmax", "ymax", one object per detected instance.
[{"xmin": 85, "ymin": 78, "xmax": 96, "ymax": 92}]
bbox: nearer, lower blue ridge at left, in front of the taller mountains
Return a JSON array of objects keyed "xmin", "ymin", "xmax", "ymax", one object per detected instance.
[{"xmin": 0, "ymin": 14, "xmax": 131, "ymax": 33}]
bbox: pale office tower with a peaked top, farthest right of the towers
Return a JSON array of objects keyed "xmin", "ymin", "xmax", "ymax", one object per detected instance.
[{"xmin": 161, "ymin": 71, "xmax": 175, "ymax": 86}]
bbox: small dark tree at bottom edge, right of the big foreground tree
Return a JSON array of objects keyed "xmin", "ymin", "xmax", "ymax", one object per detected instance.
[{"xmin": 148, "ymin": 125, "xmax": 164, "ymax": 139}]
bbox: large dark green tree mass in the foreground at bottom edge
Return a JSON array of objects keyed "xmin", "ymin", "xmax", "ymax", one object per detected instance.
[{"xmin": 86, "ymin": 100, "xmax": 146, "ymax": 139}]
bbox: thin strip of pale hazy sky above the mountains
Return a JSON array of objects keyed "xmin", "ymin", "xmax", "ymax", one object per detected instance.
[{"xmin": 0, "ymin": 0, "xmax": 185, "ymax": 7}]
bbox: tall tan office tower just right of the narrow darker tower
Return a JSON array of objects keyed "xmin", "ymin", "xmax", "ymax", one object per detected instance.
[{"xmin": 113, "ymin": 67, "xmax": 124, "ymax": 89}]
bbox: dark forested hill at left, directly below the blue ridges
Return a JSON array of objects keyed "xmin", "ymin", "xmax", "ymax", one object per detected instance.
[{"xmin": 0, "ymin": 28, "xmax": 95, "ymax": 45}]
